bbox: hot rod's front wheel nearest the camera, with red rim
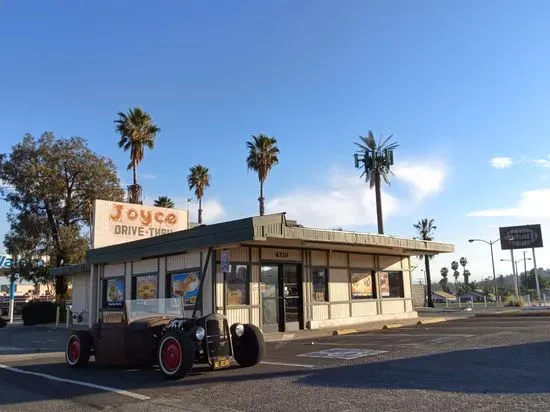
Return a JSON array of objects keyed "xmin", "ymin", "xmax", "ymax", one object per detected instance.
[{"xmin": 158, "ymin": 331, "xmax": 195, "ymax": 379}]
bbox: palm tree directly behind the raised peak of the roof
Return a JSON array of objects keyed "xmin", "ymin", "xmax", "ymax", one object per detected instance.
[{"xmin": 246, "ymin": 134, "xmax": 279, "ymax": 216}]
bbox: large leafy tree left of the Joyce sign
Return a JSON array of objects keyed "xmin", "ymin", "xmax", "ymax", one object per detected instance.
[{"xmin": 0, "ymin": 133, "xmax": 124, "ymax": 300}]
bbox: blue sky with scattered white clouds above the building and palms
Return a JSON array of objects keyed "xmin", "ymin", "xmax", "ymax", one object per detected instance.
[{"xmin": 0, "ymin": 0, "xmax": 550, "ymax": 279}]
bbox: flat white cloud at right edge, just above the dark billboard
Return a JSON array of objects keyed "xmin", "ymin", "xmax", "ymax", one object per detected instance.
[{"xmin": 468, "ymin": 189, "xmax": 550, "ymax": 218}]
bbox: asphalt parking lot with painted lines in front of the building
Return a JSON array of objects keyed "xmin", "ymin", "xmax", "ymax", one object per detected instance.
[{"xmin": 0, "ymin": 317, "xmax": 550, "ymax": 411}]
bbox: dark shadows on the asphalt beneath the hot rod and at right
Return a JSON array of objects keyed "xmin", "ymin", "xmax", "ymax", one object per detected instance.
[{"xmin": 0, "ymin": 341, "xmax": 550, "ymax": 405}]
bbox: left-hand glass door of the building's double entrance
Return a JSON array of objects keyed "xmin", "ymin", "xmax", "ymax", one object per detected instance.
[{"xmin": 260, "ymin": 265, "xmax": 281, "ymax": 332}]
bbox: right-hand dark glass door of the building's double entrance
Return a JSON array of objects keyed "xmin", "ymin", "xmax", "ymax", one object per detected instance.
[{"xmin": 282, "ymin": 265, "xmax": 302, "ymax": 331}]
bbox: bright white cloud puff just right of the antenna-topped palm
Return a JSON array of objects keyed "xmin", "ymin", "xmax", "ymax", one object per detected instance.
[{"xmin": 393, "ymin": 163, "xmax": 446, "ymax": 200}]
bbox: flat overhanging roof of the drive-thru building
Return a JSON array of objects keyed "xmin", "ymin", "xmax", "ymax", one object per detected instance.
[{"xmin": 87, "ymin": 213, "xmax": 454, "ymax": 264}]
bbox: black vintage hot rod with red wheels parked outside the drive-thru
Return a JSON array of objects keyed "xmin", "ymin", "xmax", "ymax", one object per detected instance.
[{"xmin": 65, "ymin": 248, "xmax": 265, "ymax": 379}]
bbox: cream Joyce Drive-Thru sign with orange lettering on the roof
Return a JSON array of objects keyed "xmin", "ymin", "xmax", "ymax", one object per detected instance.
[{"xmin": 93, "ymin": 200, "xmax": 187, "ymax": 248}]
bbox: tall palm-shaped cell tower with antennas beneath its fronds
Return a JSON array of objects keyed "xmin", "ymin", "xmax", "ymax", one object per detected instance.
[{"xmin": 355, "ymin": 130, "xmax": 398, "ymax": 234}]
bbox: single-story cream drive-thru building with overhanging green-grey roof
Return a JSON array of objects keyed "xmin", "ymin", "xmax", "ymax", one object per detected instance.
[{"xmin": 52, "ymin": 213, "xmax": 454, "ymax": 332}]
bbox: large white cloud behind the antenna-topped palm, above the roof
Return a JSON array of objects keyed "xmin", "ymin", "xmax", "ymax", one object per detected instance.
[{"xmin": 266, "ymin": 163, "xmax": 445, "ymax": 228}]
